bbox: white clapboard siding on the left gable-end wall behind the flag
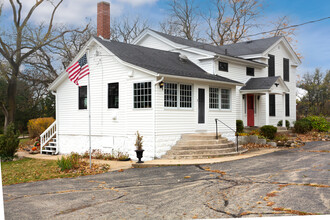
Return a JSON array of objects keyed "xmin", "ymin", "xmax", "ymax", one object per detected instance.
[{"xmin": 57, "ymin": 45, "xmax": 154, "ymax": 136}]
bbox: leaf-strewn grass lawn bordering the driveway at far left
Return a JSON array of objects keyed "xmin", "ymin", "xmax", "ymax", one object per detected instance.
[{"xmin": 1, "ymin": 158, "xmax": 91, "ymax": 185}]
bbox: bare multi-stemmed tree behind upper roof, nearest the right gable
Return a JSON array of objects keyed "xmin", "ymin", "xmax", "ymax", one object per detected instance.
[{"xmin": 205, "ymin": 0, "xmax": 262, "ymax": 46}]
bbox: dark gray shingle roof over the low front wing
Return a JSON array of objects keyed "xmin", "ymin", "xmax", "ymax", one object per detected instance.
[{"xmin": 94, "ymin": 37, "xmax": 241, "ymax": 84}]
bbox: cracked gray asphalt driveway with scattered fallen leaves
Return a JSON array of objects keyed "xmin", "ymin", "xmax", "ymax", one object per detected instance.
[{"xmin": 3, "ymin": 142, "xmax": 330, "ymax": 220}]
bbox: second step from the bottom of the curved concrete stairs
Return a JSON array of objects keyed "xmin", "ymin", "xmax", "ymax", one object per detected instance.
[{"xmin": 167, "ymin": 147, "xmax": 242, "ymax": 156}]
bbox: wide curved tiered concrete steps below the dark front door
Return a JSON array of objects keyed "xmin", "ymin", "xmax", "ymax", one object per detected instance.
[{"xmin": 162, "ymin": 133, "xmax": 246, "ymax": 159}]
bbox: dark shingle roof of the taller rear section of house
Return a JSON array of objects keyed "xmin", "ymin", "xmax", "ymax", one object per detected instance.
[{"xmin": 151, "ymin": 30, "xmax": 281, "ymax": 57}]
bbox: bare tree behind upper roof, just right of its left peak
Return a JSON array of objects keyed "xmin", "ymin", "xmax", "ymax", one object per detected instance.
[{"xmin": 160, "ymin": 0, "xmax": 200, "ymax": 41}]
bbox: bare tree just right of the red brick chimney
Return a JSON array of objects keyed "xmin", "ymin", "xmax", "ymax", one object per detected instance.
[{"xmin": 110, "ymin": 15, "xmax": 149, "ymax": 43}]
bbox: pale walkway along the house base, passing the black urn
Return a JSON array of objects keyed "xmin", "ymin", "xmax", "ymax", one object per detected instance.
[{"xmin": 17, "ymin": 148, "xmax": 280, "ymax": 171}]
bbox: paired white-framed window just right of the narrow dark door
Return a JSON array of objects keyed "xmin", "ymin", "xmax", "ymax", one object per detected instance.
[{"xmin": 209, "ymin": 88, "xmax": 230, "ymax": 110}]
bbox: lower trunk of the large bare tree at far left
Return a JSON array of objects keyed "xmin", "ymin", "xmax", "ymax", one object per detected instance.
[{"xmin": 7, "ymin": 69, "xmax": 19, "ymax": 128}]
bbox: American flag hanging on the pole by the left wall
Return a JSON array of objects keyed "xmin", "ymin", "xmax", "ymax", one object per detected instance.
[{"xmin": 66, "ymin": 54, "xmax": 89, "ymax": 86}]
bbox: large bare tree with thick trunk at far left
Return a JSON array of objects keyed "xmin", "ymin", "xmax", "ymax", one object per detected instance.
[{"xmin": 0, "ymin": 0, "xmax": 87, "ymax": 130}]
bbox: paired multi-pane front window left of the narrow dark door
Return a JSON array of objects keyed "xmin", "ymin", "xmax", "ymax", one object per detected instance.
[{"xmin": 164, "ymin": 83, "xmax": 192, "ymax": 108}]
